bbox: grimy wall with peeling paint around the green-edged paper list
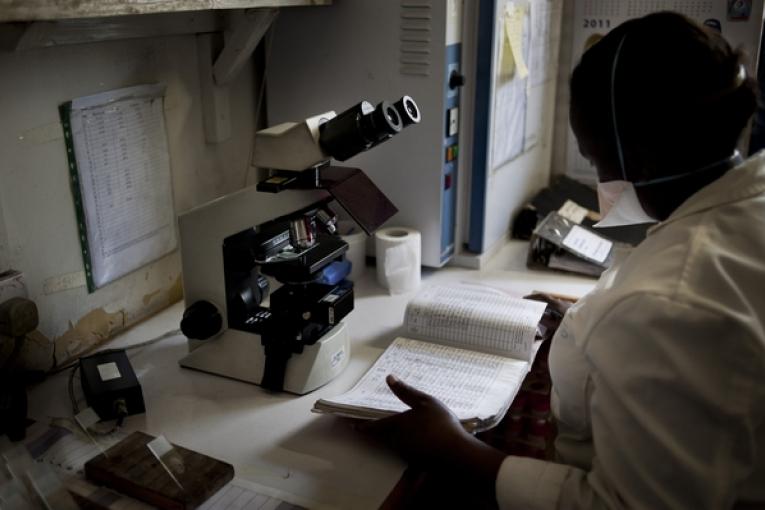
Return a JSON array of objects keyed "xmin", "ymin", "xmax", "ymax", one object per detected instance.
[{"xmin": 0, "ymin": 30, "xmax": 258, "ymax": 360}]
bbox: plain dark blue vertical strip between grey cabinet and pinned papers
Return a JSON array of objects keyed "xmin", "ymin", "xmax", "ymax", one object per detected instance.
[{"xmin": 468, "ymin": 0, "xmax": 495, "ymax": 253}]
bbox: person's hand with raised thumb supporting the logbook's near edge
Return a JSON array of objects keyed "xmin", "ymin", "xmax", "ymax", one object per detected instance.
[{"xmin": 362, "ymin": 375, "xmax": 505, "ymax": 495}]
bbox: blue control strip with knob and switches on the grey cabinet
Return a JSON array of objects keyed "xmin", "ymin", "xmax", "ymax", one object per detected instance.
[{"xmin": 441, "ymin": 43, "xmax": 462, "ymax": 263}]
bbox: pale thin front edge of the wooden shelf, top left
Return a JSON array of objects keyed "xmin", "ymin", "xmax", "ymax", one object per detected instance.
[{"xmin": 0, "ymin": 0, "xmax": 332, "ymax": 22}]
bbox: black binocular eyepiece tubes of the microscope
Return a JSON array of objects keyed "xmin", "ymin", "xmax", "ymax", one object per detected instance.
[{"xmin": 319, "ymin": 96, "xmax": 420, "ymax": 161}]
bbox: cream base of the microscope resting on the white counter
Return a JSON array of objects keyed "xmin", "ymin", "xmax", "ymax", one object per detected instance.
[{"xmin": 179, "ymin": 322, "xmax": 351, "ymax": 395}]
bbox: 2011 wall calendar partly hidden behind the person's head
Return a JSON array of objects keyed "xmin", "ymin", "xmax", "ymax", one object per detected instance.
[{"xmin": 566, "ymin": 0, "xmax": 763, "ymax": 184}]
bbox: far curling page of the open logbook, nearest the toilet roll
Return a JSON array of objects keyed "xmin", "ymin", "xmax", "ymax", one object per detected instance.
[{"xmin": 404, "ymin": 284, "xmax": 546, "ymax": 361}]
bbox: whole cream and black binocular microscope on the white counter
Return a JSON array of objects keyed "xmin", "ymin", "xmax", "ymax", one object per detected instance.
[{"xmin": 179, "ymin": 96, "xmax": 420, "ymax": 395}]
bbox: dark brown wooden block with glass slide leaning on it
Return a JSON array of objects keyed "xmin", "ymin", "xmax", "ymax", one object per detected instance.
[{"xmin": 85, "ymin": 432, "xmax": 234, "ymax": 510}]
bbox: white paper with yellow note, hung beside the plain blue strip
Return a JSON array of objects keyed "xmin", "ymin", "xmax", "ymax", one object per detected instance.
[{"xmin": 491, "ymin": 1, "xmax": 531, "ymax": 171}]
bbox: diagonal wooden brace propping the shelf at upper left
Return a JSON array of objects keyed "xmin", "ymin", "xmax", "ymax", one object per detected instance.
[{"xmin": 213, "ymin": 9, "xmax": 279, "ymax": 85}]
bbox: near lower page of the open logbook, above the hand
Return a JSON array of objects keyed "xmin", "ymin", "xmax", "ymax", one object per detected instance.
[{"xmin": 317, "ymin": 338, "xmax": 528, "ymax": 421}]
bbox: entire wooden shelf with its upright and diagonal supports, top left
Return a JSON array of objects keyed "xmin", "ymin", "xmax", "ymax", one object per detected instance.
[{"xmin": 0, "ymin": 0, "xmax": 332, "ymax": 143}]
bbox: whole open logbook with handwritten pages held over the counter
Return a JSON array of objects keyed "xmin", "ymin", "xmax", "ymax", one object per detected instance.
[{"xmin": 313, "ymin": 284, "xmax": 546, "ymax": 431}]
